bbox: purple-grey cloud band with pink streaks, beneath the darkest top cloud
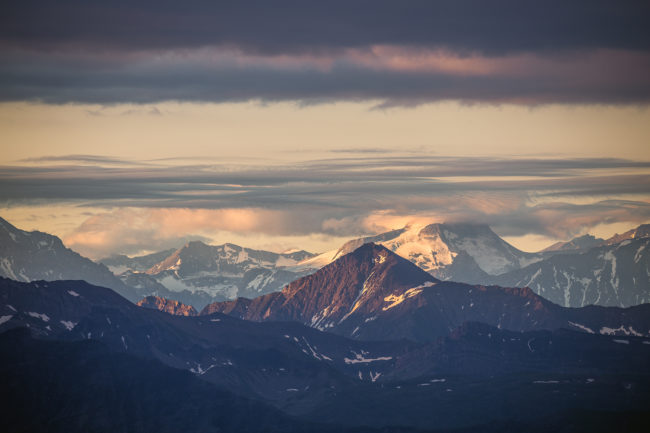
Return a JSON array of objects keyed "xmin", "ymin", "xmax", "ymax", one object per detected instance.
[{"xmin": 5, "ymin": 45, "xmax": 650, "ymax": 105}]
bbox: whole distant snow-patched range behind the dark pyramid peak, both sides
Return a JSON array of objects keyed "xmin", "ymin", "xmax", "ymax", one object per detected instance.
[{"xmin": 0, "ymin": 214, "xmax": 650, "ymax": 309}]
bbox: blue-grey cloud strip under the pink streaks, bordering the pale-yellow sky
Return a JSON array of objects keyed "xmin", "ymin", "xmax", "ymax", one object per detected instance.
[{"xmin": 0, "ymin": 52, "xmax": 650, "ymax": 105}]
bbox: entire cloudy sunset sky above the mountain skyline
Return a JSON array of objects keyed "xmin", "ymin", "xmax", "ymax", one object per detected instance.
[{"xmin": 0, "ymin": 0, "xmax": 650, "ymax": 258}]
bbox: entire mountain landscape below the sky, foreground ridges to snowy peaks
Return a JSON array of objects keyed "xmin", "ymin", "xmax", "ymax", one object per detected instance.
[{"xmin": 0, "ymin": 220, "xmax": 650, "ymax": 433}]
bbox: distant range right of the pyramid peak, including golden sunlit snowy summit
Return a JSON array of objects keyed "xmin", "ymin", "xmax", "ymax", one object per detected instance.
[{"xmin": 306, "ymin": 224, "xmax": 650, "ymax": 307}]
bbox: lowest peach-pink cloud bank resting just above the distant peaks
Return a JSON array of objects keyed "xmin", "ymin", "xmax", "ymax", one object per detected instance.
[{"xmin": 55, "ymin": 194, "xmax": 650, "ymax": 258}]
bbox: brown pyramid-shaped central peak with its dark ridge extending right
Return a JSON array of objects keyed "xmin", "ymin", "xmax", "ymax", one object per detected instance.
[{"xmin": 201, "ymin": 244, "xmax": 650, "ymax": 341}]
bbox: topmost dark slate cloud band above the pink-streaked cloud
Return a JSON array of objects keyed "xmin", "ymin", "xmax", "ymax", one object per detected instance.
[{"xmin": 0, "ymin": 0, "xmax": 650, "ymax": 54}]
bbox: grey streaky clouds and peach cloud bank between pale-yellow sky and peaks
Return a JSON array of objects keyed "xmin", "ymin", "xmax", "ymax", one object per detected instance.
[{"xmin": 0, "ymin": 155, "xmax": 650, "ymax": 256}]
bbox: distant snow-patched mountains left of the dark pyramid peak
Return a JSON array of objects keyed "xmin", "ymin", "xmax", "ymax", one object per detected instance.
[{"xmin": 0, "ymin": 218, "xmax": 313, "ymax": 308}]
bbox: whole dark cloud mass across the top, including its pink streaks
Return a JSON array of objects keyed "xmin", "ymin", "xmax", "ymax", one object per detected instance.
[{"xmin": 0, "ymin": 0, "xmax": 650, "ymax": 105}]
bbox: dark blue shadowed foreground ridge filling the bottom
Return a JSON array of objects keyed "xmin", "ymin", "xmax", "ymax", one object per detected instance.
[{"xmin": 0, "ymin": 276, "xmax": 650, "ymax": 431}]
